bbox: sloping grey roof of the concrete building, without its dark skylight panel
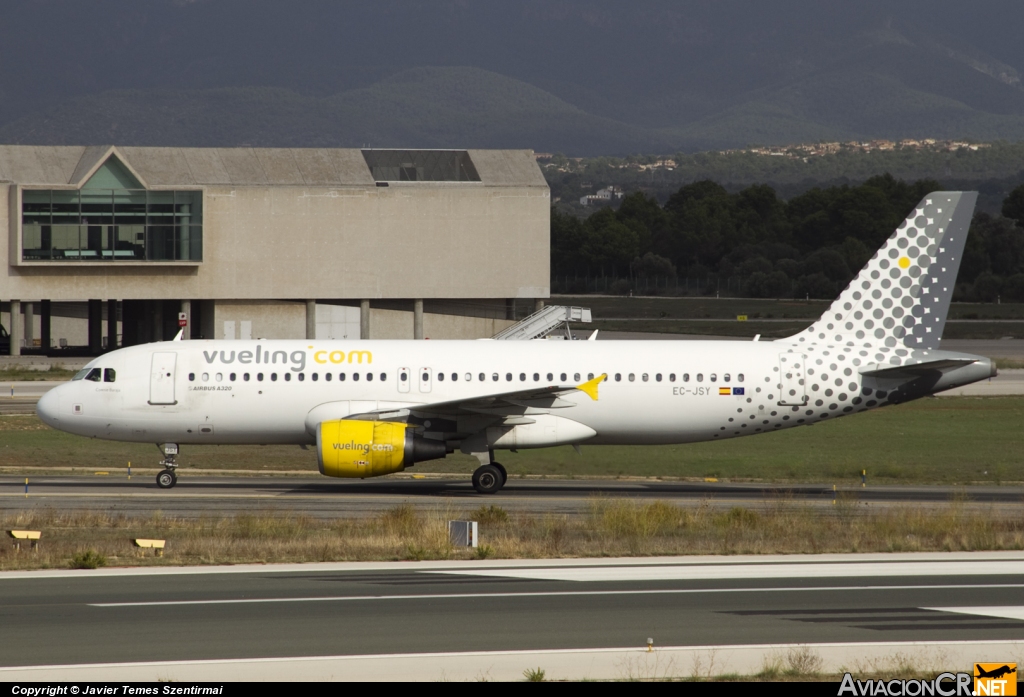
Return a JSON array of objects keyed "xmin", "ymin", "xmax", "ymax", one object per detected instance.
[{"xmin": 0, "ymin": 145, "xmax": 548, "ymax": 187}]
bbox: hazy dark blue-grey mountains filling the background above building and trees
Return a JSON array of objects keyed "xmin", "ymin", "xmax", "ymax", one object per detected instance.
[{"xmin": 0, "ymin": 0, "xmax": 1024, "ymax": 156}]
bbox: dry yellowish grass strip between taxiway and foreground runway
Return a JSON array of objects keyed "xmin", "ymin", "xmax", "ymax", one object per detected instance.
[{"xmin": 0, "ymin": 497, "xmax": 1024, "ymax": 569}]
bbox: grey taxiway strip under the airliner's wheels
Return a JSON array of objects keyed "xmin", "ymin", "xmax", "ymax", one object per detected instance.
[{"xmin": 0, "ymin": 470, "xmax": 1024, "ymax": 518}]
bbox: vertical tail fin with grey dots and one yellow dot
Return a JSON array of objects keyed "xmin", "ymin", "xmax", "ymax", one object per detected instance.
[{"xmin": 792, "ymin": 191, "xmax": 978, "ymax": 354}]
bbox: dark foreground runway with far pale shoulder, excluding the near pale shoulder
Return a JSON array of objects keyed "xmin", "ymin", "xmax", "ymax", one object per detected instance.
[{"xmin": 0, "ymin": 555, "xmax": 1024, "ymax": 666}]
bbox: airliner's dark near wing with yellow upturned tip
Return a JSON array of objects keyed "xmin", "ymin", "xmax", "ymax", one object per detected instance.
[{"xmin": 347, "ymin": 374, "xmax": 608, "ymax": 421}]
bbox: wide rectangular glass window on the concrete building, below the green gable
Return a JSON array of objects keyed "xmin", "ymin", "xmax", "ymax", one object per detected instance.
[{"xmin": 22, "ymin": 188, "xmax": 203, "ymax": 262}]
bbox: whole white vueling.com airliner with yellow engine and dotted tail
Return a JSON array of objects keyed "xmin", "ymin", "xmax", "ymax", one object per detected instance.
[{"xmin": 37, "ymin": 191, "xmax": 995, "ymax": 493}]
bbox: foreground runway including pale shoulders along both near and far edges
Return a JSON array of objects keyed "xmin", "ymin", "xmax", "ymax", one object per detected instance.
[{"xmin": 0, "ymin": 553, "xmax": 1024, "ymax": 681}]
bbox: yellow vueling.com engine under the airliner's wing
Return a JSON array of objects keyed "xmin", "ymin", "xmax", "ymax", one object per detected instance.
[{"xmin": 316, "ymin": 420, "xmax": 447, "ymax": 479}]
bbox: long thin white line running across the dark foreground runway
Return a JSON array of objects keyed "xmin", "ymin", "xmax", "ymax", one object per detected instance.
[{"xmin": 88, "ymin": 583, "xmax": 1024, "ymax": 601}]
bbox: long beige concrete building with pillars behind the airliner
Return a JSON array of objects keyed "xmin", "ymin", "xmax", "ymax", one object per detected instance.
[{"xmin": 0, "ymin": 145, "xmax": 550, "ymax": 355}]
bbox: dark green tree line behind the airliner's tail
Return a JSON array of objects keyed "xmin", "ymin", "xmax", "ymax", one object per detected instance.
[{"xmin": 551, "ymin": 174, "xmax": 1024, "ymax": 302}]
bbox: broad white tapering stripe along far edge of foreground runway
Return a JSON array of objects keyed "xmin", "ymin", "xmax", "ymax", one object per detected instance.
[{"xmin": 424, "ymin": 561, "xmax": 1024, "ymax": 581}]
